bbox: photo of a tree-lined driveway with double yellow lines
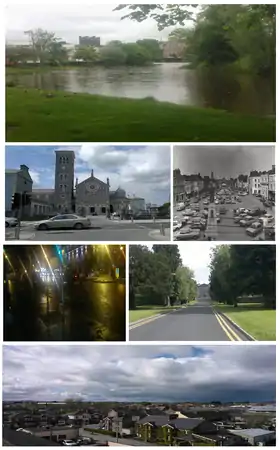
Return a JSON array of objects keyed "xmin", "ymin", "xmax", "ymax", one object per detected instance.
[{"xmin": 129, "ymin": 242, "xmax": 276, "ymax": 342}]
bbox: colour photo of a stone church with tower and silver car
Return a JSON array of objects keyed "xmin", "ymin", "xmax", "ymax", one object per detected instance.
[{"xmin": 5, "ymin": 144, "xmax": 170, "ymax": 242}]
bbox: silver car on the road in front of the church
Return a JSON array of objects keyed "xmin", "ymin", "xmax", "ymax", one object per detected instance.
[{"xmin": 35, "ymin": 214, "xmax": 91, "ymax": 231}]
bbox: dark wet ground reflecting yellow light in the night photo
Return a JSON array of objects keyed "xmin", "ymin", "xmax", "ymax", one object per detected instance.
[{"xmin": 4, "ymin": 279, "xmax": 125, "ymax": 341}]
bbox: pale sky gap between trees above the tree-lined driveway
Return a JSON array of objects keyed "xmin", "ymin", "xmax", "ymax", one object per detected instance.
[{"xmin": 147, "ymin": 242, "xmax": 214, "ymax": 284}]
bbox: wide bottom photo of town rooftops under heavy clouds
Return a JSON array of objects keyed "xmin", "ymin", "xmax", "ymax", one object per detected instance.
[{"xmin": 3, "ymin": 344, "xmax": 276, "ymax": 447}]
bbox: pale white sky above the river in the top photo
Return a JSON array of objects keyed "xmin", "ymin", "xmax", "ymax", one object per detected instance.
[{"xmin": 6, "ymin": 0, "xmax": 192, "ymax": 44}]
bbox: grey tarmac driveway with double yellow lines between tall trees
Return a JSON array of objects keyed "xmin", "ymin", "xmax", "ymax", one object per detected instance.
[{"xmin": 129, "ymin": 300, "xmax": 250, "ymax": 341}]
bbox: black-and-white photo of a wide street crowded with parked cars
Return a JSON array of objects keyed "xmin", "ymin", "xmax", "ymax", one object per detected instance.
[{"xmin": 173, "ymin": 146, "xmax": 275, "ymax": 241}]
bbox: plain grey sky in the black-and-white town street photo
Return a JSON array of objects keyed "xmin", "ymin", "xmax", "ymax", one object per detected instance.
[{"xmin": 173, "ymin": 145, "xmax": 275, "ymax": 178}]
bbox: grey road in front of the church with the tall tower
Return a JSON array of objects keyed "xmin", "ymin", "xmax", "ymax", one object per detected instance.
[{"xmin": 6, "ymin": 216, "xmax": 170, "ymax": 242}]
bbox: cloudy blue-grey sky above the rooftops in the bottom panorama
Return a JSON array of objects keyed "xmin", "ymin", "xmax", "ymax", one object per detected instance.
[{"xmin": 3, "ymin": 345, "xmax": 276, "ymax": 402}]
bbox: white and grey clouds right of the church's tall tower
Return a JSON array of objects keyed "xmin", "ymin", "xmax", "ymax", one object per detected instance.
[{"xmin": 76, "ymin": 144, "xmax": 170, "ymax": 203}]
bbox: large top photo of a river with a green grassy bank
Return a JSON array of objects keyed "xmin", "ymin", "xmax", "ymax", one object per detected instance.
[{"xmin": 5, "ymin": 2, "xmax": 276, "ymax": 142}]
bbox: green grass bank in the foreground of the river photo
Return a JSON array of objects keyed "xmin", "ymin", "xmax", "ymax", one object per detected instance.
[{"xmin": 6, "ymin": 87, "xmax": 275, "ymax": 142}]
